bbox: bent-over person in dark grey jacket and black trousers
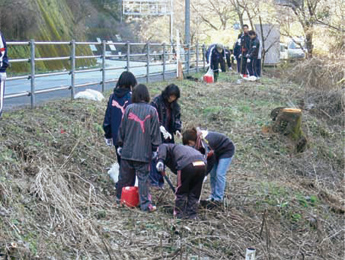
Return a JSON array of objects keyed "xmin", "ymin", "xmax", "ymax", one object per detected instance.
[{"xmin": 156, "ymin": 144, "xmax": 206, "ymax": 219}]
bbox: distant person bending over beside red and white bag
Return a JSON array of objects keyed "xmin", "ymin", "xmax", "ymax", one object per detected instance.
[{"xmin": 206, "ymin": 43, "xmax": 231, "ymax": 82}]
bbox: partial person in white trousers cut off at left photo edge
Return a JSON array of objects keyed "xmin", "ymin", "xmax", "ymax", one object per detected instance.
[{"xmin": 0, "ymin": 32, "xmax": 9, "ymax": 118}]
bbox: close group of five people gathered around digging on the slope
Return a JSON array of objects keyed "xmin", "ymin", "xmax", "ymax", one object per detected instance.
[{"xmin": 103, "ymin": 72, "xmax": 235, "ymax": 219}]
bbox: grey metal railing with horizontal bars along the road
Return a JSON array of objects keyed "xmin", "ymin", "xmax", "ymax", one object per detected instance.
[{"xmin": 5, "ymin": 40, "xmax": 206, "ymax": 108}]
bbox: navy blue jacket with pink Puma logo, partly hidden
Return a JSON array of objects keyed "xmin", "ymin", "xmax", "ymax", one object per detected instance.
[{"xmin": 103, "ymin": 88, "xmax": 132, "ymax": 145}]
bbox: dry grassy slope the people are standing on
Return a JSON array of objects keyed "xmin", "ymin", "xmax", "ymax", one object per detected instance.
[{"xmin": 0, "ymin": 70, "xmax": 344, "ymax": 260}]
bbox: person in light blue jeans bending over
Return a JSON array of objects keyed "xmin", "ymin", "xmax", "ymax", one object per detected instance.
[{"xmin": 182, "ymin": 128, "xmax": 235, "ymax": 202}]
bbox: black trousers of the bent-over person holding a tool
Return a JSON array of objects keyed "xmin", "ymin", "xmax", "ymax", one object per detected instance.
[{"xmin": 174, "ymin": 164, "xmax": 206, "ymax": 219}]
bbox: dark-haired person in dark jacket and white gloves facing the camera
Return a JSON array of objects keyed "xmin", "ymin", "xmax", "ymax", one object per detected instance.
[{"xmin": 150, "ymin": 84, "xmax": 182, "ymax": 187}]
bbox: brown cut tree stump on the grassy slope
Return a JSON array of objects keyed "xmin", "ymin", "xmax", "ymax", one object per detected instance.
[{"xmin": 271, "ymin": 107, "xmax": 307, "ymax": 152}]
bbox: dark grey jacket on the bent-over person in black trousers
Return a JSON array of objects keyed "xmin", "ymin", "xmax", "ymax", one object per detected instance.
[{"xmin": 158, "ymin": 144, "xmax": 206, "ymax": 174}]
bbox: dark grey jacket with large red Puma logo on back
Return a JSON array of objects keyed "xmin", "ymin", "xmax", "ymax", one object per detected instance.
[{"xmin": 117, "ymin": 102, "xmax": 162, "ymax": 163}]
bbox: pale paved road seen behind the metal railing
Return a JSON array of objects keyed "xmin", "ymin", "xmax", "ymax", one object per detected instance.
[{"xmin": 4, "ymin": 60, "xmax": 176, "ymax": 110}]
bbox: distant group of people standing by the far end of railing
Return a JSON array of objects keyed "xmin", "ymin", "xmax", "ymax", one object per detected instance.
[{"xmin": 206, "ymin": 24, "xmax": 262, "ymax": 82}]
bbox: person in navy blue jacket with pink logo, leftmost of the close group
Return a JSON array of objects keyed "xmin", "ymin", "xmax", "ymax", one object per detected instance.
[{"xmin": 103, "ymin": 71, "xmax": 137, "ymax": 165}]
